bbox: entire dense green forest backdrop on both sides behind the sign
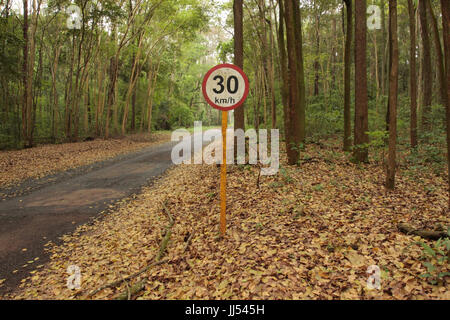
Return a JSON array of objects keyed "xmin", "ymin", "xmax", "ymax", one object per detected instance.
[{"xmin": 0, "ymin": 0, "xmax": 448, "ymax": 191}]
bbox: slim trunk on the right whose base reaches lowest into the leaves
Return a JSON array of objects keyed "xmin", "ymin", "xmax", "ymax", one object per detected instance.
[{"xmin": 386, "ymin": 0, "xmax": 398, "ymax": 190}]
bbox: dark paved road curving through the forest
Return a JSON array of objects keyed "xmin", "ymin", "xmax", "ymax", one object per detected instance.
[{"xmin": 0, "ymin": 135, "xmax": 204, "ymax": 298}]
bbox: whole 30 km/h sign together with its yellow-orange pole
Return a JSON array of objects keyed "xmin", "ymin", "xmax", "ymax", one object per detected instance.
[{"xmin": 202, "ymin": 64, "xmax": 249, "ymax": 236}]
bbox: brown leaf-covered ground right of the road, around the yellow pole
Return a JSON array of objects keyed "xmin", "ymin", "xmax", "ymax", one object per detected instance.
[{"xmin": 0, "ymin": 140, "xmax": 450, "ymax": 299}]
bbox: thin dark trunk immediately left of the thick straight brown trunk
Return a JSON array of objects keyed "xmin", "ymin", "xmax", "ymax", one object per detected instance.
[{"xmin": 344, "ymin": 0, "xmax": 353, "ymax": 151}]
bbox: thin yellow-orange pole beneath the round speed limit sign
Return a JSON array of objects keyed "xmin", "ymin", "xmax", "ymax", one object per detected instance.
[{"xmin": 220, "ymin": 111, "xmax": 228, "ymax": 236}]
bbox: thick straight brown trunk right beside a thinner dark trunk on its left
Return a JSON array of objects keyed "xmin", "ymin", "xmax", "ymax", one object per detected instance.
[{"xmin": 353, "ymin": 0, "xmax": 369, "ymax": 162}]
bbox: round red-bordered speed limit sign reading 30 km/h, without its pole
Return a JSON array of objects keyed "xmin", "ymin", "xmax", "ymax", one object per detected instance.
[{"xmin": 202, "ymin": 64, "xmax": 249, "ymax": 111}]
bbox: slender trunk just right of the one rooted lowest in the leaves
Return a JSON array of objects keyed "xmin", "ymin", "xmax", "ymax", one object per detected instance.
[{"xmin": 408, "ymin": 0, "xmax": 417, "ymax": 148}]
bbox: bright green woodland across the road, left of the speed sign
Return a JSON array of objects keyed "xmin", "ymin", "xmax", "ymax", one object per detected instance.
[{"xmin": 0, "ymin": 0, "xmax": 221, "ymax": 148}]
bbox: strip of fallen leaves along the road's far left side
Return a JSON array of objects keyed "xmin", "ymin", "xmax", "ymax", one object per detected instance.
[{"xmin": 0, "ymin": 131, "xmax": 170, "ymax": 189}]
